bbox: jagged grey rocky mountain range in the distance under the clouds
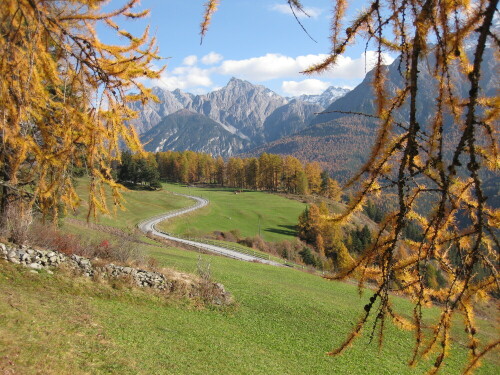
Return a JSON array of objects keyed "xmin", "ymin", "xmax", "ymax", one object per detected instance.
[{"xmin": 132, "ymin": 78, "xmax": 346, "ymax": 156}]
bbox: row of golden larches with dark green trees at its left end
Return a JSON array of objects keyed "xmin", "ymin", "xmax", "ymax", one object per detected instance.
[{"xmin": 116, "ymin": 151, "xmax": 342, "ymax": 201}]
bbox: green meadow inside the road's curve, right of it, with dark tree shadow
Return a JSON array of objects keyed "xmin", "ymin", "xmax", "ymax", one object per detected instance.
[{"xmin": 158, "ymin": 184, "xmax": 305, "ymax": 241}]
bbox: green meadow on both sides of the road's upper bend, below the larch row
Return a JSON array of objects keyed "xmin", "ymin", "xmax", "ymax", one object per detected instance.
[{"xmin": 68, "ymin": 179, "xmax": 305, "ymax": 245}]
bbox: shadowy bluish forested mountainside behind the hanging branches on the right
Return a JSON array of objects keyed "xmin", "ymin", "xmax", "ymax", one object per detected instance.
[{"xmin": 246, "ymin": 48, "xmax": 500, "ymax": 181}]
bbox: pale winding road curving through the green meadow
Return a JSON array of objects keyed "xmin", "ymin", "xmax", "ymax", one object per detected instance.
[{"xmin": 137, "ymin": 194, "xmax": 283, "ymax": 266}]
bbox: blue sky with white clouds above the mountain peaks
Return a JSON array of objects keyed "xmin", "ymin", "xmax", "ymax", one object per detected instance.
[{"xmin": 105, "ymin": 0, "xmax": 390, "ymax": 96}]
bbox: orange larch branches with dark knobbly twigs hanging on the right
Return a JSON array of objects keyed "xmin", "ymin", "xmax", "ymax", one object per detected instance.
[{"xmin": 201, "ymin": 0, "xmax": 500, "ymax": 374}]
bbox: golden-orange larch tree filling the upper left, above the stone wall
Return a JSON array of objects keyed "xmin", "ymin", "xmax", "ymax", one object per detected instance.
[{"xmin": 0, "ymin": 0, "xmax": 160, "ymax": 229}]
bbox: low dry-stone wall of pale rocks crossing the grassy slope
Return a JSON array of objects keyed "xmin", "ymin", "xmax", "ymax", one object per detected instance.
[{"xmin": 0, "ymin": 243, "xmax": 232, "ymax": 305}]
